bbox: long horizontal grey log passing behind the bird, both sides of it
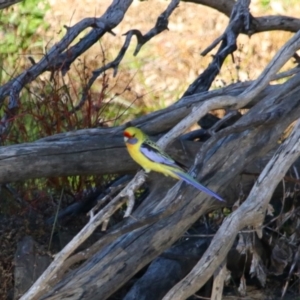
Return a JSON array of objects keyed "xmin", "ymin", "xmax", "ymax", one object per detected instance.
[{"xmin": 0, "ymin": 77, "xmax": 292, "ymax": 183}]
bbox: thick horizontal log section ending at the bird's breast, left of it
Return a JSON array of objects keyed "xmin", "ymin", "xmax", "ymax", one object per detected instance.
[{"xmin": 0, "ymin": 134, "xmax": 132, "ymax": 183}]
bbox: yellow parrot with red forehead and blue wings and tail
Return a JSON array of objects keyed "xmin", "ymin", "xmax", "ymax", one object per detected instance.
[{"xmin": 123, "ymin": 127, "xmax": 225, "ymax": 201}]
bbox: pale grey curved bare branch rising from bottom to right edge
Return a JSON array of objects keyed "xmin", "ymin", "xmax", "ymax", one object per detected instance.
[{"xmin": 163, "ymin": 121, "xmax": 300, "ymax": 300}]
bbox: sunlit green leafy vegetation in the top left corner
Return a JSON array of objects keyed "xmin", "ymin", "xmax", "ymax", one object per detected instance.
[{"xmin": 0, "ymin": 0, "xmax": 50, "ymax": 84}]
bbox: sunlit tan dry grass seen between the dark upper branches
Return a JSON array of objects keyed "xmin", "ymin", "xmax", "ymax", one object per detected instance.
[{"xmin": 47, "ymin": 0, "xmax": 300, "ymax": 113}]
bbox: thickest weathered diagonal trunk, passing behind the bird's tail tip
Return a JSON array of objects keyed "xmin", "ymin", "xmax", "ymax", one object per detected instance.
[{"xmin": 39, "ymin": 76, "xmax": 300, "ymax": 299}]
